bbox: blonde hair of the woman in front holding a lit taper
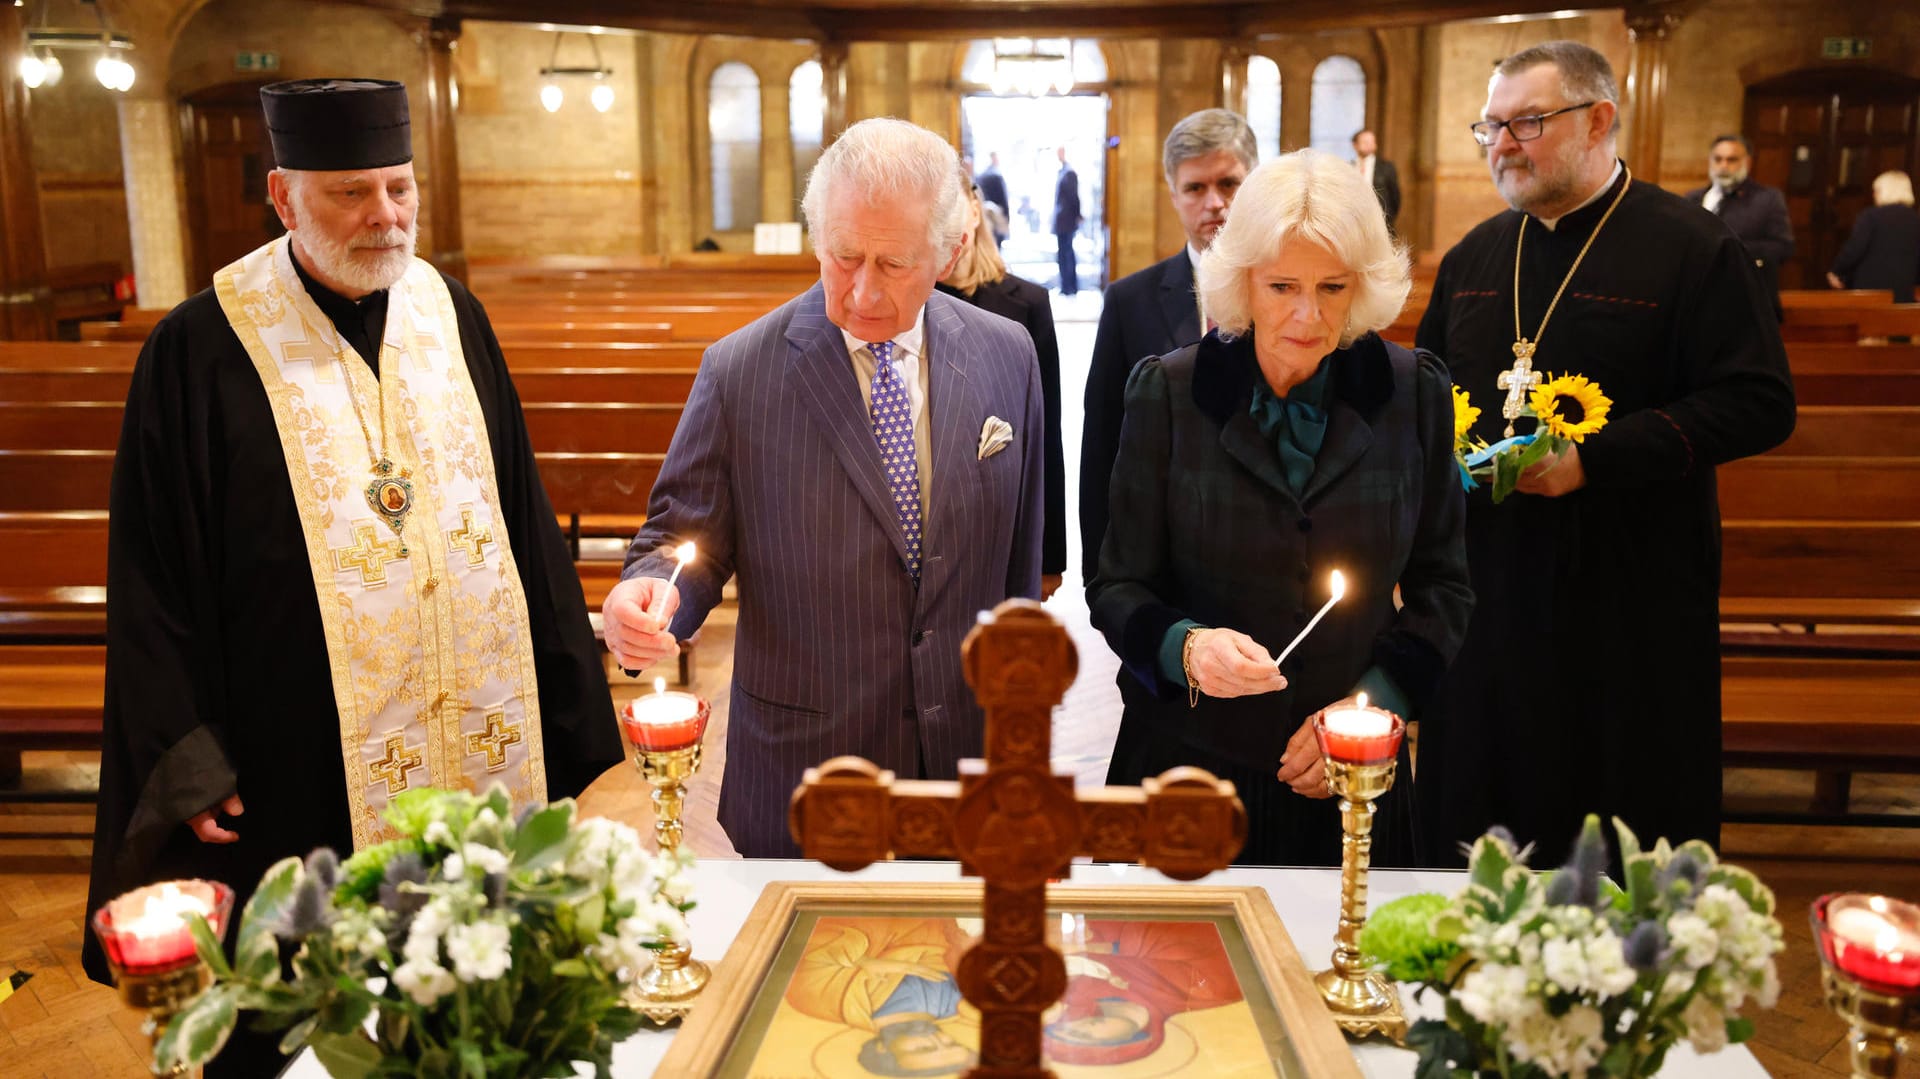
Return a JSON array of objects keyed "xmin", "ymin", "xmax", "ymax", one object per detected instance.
[{"xmin": 1194, "ymin": 150, "xmax": 1413, "ymax": 348}]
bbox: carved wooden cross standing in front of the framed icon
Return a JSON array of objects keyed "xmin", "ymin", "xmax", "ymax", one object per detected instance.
[{"xmin": 789, "ymin": 599, "xmax": 1246, "ymax": 1079}]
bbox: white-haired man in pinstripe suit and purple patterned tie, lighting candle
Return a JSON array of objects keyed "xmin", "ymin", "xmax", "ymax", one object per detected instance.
[{"xmin": 603, "ymin": 119, "xmax": 1044, "ymax": 856}]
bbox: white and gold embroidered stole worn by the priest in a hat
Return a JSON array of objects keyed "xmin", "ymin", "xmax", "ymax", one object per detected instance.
[{"xmin": 213, "ymin": 236, "xmax": 547, "ymax": 849}]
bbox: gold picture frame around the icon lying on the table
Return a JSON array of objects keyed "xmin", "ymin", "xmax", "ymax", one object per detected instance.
[{"xmin": 659, "ymin": 881, "xmax": 1361, "ymax": 1079}]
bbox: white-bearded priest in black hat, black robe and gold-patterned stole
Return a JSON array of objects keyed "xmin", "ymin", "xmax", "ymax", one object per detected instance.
[{"xmin": 86, "ymin": 79, "xmax": 620, "ymax": 1075}]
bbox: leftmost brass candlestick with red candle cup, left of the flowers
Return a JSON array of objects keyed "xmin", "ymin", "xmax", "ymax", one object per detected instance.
[{"xmin": 92, "ymin": 881, "xmax": 234, "ymax": 1075}]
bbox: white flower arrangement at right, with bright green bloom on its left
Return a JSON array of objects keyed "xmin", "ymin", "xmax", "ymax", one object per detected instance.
[{"xmin": 1359, "ymin": 816, "xmax": 1782, "ymax": 1079}]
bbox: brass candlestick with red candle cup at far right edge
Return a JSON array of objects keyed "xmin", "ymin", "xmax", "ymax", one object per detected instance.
[{"xmin": 1812, "ymin": 895, "xmax": 1920, "ymax": 1079}]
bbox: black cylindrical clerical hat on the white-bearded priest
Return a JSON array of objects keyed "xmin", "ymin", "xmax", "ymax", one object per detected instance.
[{"xmin": 259, "ymin": 79, "xmax": 413, "ymax": 173}]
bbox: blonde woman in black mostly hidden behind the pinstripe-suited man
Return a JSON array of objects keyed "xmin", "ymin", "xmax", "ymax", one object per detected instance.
[{"xmin": 935, "ymin": 169, "xmax": 1068, "ymax": 599}]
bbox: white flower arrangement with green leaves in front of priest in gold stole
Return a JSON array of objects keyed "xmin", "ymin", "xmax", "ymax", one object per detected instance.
[{"xmin": 156, "ymin": 787, "xmax": 693, "ymax": 1079}]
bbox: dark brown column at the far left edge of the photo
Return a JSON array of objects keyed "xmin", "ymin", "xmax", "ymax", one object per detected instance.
[{"xmin": 0, "ymin": 0, "xmax": 52, "ymax": 340}]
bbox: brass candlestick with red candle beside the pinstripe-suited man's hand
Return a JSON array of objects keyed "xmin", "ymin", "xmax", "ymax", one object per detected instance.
[{"xmin": 624, "ymin": 691, "xmax": 712, "ymax": 1023}]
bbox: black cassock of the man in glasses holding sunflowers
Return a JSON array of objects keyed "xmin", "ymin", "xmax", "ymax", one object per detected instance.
[{"xmin": 1419, "ymin": 166, "xmax": 1793, "ymax": 866}]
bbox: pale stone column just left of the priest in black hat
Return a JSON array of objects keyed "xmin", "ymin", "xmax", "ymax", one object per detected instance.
[{"xmin": 117, "ymin": 91, "xmax": 188, "ymax": 309}]
